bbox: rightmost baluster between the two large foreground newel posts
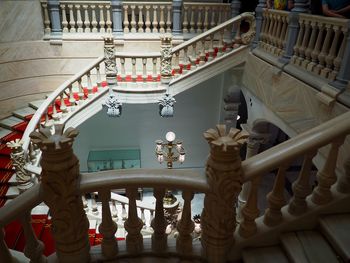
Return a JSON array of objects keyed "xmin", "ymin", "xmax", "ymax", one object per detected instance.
[{"xmin": 176, "ymin": 191, "xmax": 194, "ymax": 253}]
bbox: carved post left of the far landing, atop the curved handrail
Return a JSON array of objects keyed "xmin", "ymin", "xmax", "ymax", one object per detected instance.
[{"xmin": 104, "ymin": 37, "xmax": 118, "ymax": 87}]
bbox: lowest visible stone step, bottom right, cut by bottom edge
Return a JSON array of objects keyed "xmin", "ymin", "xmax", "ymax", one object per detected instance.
[{"xmin": 242, "ymin": 246, "xmax": 289, "ymax": 263}]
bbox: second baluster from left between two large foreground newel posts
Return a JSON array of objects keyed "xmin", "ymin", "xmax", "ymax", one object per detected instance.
[{"xmin": 124, "ymin": 188, "xmax": 143, "ymax": 253}]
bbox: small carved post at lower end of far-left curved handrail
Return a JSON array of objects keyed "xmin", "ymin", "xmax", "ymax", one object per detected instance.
[{"xmin": 6, "ymin": 139, "xmax": 33, "ymax": 193}]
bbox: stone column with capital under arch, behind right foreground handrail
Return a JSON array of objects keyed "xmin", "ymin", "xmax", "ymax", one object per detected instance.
[{"xmin": 237, "ymin": 124, "xmax": 269, "ymax": 221}]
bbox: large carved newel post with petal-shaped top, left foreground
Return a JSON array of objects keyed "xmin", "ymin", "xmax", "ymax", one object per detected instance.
[{"xmin": 30, "ymin": 124, "xmax": 90, "ymax": 263}]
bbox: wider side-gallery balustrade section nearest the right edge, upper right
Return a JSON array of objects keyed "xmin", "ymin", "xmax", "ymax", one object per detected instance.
[{"xmin": 291, "ymin": 14, "xmax": 349, "ymax": 80}]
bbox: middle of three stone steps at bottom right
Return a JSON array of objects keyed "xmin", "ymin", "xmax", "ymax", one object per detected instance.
[{"xmin": 281, "ymin": 231, "xmax": 339, "ymax": 263}]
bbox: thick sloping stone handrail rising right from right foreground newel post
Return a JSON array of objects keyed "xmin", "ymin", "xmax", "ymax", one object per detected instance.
[{"xmin": 242, "ymin": 111, "xmax": 350, "ymax": 182}]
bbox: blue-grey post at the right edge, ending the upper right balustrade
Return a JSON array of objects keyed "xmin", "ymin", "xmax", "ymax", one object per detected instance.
[{"xmin": 331, "ymin": 24, "xmax": 350, "ymax": 90}]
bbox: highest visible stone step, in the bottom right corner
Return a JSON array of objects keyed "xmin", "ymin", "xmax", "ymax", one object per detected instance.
[{"xmin": 319, "ymin": 214, "xmax": 350, "ymax": 262}]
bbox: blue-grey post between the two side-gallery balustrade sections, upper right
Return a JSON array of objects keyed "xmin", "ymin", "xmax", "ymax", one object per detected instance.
[{"xmin": 280, "ymin": 0, "xmax": 308, "ymax": 63}]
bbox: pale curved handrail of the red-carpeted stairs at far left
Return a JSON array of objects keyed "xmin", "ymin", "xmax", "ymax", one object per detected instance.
[{"xmin": 22, "ymin": 56, "xmax": 104, "ymax": 153}]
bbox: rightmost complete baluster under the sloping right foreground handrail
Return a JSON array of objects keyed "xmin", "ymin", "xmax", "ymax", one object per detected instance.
[{"xmin": 311, "ymin": 137, "xmax": 345, "ymax": 205}]
